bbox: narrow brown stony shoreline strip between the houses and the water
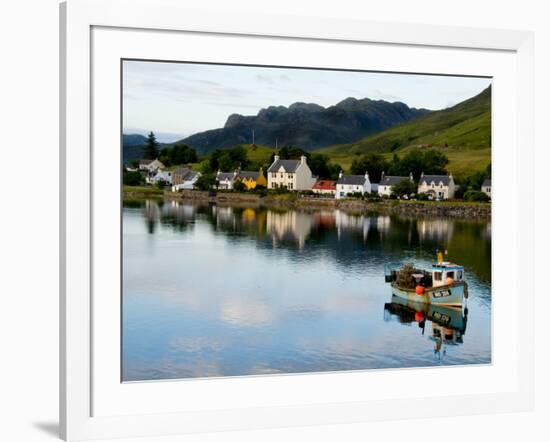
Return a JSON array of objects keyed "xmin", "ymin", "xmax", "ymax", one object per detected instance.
[{"xmin": 123, "ymin": 189, "xmax": 491, "ymax": 220}]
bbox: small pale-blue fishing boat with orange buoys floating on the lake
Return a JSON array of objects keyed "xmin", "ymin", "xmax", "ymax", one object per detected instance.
[{"xmin": 385, "ymin": 253, "xmax": 468, "ymax": 307}]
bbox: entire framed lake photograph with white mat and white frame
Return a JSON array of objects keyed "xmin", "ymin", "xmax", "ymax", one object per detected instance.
[{"xmin": 61, "ymin": 0, "xmax": 534, "ymax": 440}]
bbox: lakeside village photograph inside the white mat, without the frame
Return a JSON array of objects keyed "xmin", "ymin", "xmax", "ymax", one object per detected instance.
[{"xmin": 123, "ymin": 59, "xmax": 493, "ymax": 382}]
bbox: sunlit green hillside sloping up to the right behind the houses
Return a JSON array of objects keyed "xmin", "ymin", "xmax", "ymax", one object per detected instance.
[{"xmin": 316, "ymin": 87, "xmax": 491, "ymax": 175}]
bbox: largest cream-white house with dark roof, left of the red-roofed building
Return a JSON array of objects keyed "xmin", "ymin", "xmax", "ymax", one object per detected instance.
[{"xmin": 267, "ymin": 155, "xmax": 316, "ymax": 190}]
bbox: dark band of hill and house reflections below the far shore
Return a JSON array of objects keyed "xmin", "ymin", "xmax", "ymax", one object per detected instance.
[{"xmin": 124, "ymin": 200, "xmax": 491, "ymax": 284}]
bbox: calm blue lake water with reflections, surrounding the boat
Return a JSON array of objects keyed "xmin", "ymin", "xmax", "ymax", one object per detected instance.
[{"xmin": 123, "ymin": 201, "xmax": 491, "ymax": 381}]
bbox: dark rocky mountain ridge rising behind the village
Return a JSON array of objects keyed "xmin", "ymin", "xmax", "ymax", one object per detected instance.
[{"xmin": 173, "ymin": 97, "xmax": 431, "ymax": 154}]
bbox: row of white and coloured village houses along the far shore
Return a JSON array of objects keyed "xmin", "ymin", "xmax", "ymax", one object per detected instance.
[{"xmin": 132, "ymin": 155, "xmax": 491, "ymax": 201}]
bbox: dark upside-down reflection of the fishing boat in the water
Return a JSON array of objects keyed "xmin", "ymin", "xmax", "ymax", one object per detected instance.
[{"xmin": 384, "ymin": 295, "xmax": 468, "ymax": 359}]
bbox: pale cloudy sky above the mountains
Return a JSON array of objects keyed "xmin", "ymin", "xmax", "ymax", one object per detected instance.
[{"xmin": 122, "ymin": 60, "xmax": 491, "ymax": 142}]
